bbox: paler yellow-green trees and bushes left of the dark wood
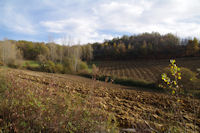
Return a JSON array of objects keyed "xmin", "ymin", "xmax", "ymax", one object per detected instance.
[{"xmin": 0, "ymin": 39, "xmax": 93, "ymax": 73}]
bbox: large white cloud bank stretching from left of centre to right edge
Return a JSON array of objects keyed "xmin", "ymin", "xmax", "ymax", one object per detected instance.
[{"xmin": 30, "ymin": 0, "xmax": 200, "ymax": 43}]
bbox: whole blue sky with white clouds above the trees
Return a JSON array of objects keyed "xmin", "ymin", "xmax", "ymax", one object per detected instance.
[{"xmin": 0, "ymin": 0, "xmax": 200, "ymax": 44}]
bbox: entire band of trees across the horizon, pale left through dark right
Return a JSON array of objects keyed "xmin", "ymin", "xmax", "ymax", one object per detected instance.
[{"xmin": 0, "ymin": 32, "xmax": 200, "ymax": 72}]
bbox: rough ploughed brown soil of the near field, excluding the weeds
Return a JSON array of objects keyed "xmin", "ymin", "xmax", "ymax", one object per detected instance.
[{"xmin": 0, "ymin": 69, "xmax": 200, "ymax": 132}]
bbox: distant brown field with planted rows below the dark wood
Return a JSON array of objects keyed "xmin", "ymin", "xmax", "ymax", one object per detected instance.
[{"xmin": 95, "ymin": 57, "xmax": 200, "ymax": 82}]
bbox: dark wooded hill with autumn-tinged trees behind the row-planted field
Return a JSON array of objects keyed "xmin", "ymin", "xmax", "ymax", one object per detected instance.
[{"xmin": 92, "ymin": 32, "xmax": 200, "ymax": 60}]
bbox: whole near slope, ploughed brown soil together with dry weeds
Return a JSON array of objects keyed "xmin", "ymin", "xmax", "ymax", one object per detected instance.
[{"xmin": 0, "ymin": 69, "xmax": 200, "ymax": 133}]
